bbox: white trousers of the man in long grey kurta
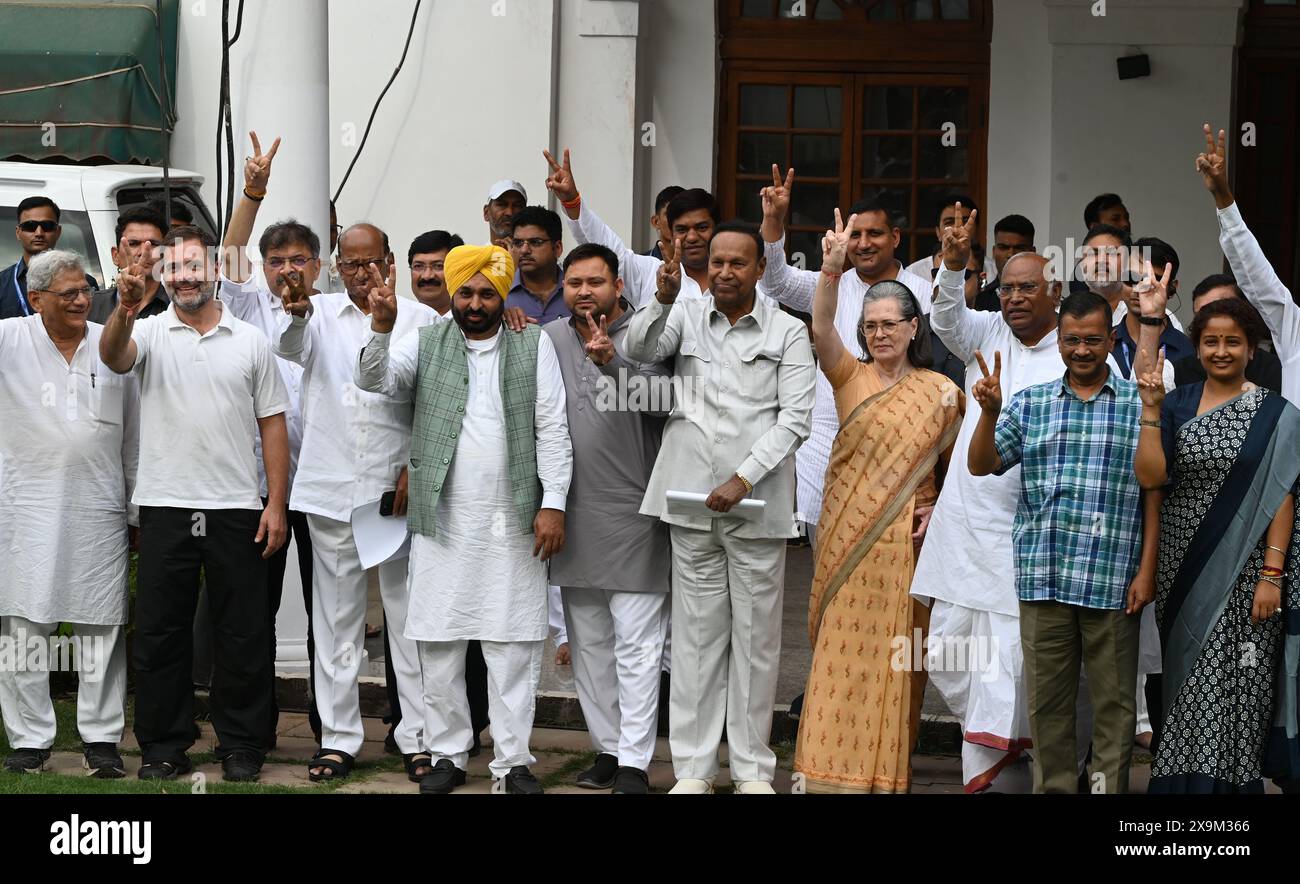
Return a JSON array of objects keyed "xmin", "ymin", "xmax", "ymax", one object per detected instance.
[{"xmin": 563, "ymin": 586, "xmax": 668, "ymax": 771}]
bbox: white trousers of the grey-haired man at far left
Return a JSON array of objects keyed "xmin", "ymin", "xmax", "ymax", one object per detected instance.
[{"xmin": 0, "ymin": 618, "xmax": 126, "ymax": 749}]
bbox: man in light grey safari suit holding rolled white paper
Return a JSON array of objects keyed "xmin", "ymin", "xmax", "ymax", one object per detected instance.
[{"xmin": 625, "ymin": 225, "xmax": 815, "ymax": 794}]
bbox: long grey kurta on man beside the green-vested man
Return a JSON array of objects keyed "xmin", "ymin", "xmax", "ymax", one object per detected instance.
[{"xmin": 542, "ymin": 300, "xmax": 672, "ymax": 593}]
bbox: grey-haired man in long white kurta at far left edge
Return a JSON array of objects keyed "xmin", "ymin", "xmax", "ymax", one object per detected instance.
[{"xmin": 0, "ymin": 251, "xmax": 139, "ymax": 779}]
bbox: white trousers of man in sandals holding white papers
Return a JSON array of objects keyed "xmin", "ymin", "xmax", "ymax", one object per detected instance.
[{"xmin": 307, "ymin": 514, "xmax": 424, "ymax": 755}]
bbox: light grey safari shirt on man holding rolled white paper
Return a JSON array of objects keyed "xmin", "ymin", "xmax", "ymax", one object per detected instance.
[{"xmin": 625, "ymin": 295, "xmax": 816, "ymax": 540}]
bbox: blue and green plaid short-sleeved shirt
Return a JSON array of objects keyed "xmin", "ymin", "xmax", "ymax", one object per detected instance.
[{"xmin": 993, "ymin": 372, "xmax": 1141, "ymax": 610}]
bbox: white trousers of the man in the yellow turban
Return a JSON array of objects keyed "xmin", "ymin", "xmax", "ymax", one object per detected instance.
[{"xmin": 417, "ymin": 641, "xmax": 546, "ymax": 779}]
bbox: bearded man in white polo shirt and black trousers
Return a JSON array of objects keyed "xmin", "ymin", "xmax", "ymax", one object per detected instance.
[{"xmin": 99, "ymin": 228, "xmax": 289, "ymax": 780}]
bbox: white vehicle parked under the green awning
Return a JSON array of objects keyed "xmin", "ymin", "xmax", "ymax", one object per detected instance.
[{"xmin": 0, "ymin": 163, "xmax": 216, "ymax": 287}]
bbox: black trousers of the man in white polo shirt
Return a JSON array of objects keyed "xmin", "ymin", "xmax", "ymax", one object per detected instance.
[{"xmin": 134, "ymin": 507, "xmax": 273, "ymax": 764}]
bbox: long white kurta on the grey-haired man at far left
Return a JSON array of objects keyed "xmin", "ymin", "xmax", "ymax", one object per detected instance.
[{"xmin": 0, "ymin": 315, "xmax": 139, "ymax": 625}]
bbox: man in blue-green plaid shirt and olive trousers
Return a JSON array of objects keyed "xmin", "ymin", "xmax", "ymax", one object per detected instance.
[{"xmin": 969, "ymin": 293, "xmax": 1158, "ymax": 793}]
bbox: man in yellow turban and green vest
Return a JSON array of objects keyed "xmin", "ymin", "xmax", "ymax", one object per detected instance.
[{"xmin": 355, "ymin": 240, "xmax": 573, "ymax": 794}]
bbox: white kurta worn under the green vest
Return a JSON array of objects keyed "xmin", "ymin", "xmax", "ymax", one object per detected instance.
[{"xmin": 358, "ymin": 325, "xmax": 573, "ymax": 642}]
